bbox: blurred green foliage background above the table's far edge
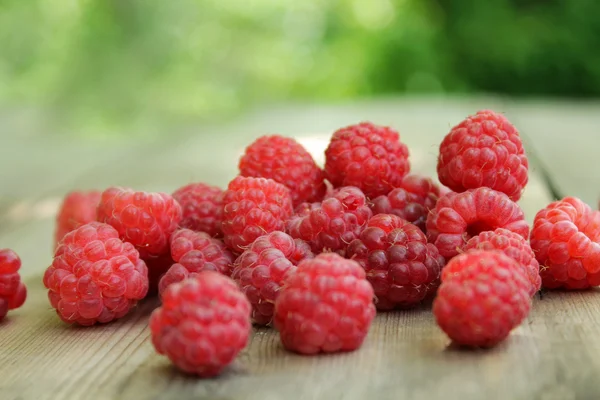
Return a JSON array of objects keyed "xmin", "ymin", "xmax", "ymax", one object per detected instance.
[{"xmin": 0, "ymin": 0, "xmax": 600, "ymax": 133}]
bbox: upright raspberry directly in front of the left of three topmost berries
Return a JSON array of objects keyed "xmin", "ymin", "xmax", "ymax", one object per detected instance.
[{"xmin": 222, "ymin": 176, "xmax": 293, "ymax": 253}]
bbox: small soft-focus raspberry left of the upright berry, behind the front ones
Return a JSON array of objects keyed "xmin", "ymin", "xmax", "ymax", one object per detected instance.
[{"xmin": 173, "ymin": 183, "xmax": 223, "ymax": 237}]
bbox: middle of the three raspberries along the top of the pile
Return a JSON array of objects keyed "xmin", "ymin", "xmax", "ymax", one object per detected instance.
[{"xmin": 325, "ymin": 122, "xmax": 410, "ymax": 198}]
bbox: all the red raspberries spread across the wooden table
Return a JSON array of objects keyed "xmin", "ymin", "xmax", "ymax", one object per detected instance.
[{"xmin": 0, "ymin": 110, "xmax": 600, "ymax": 377}]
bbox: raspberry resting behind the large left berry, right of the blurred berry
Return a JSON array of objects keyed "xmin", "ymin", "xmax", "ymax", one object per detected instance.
[{"xmin": 98, "ymin": 187, "xmax": 181, "ymax": 258}]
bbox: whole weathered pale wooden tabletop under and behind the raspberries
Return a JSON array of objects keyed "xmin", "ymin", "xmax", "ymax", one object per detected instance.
[{"xmin": 0, "ymin": 98, "xmax": 600, "ymax": 400}]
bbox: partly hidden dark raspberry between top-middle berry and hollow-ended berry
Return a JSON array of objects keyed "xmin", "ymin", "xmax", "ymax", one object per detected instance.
[{"xmin": 371, "ymin": 175, "xmax": 440, "ymax": 232}]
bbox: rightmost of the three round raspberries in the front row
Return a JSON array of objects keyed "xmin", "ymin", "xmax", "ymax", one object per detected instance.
[{"xmin": 433, "ymin": 250, "xmax": 531, "ymax": 347}]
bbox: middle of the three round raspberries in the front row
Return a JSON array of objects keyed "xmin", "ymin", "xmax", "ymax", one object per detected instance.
[{"xmin": 275, "ymin": 253, "xmax": 375, "ymax": 354}]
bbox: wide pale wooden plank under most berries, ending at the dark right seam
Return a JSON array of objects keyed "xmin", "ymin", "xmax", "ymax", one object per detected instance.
[{"xmin": 0, "ymin": 99, "xmax": 572, "ymax": 400}]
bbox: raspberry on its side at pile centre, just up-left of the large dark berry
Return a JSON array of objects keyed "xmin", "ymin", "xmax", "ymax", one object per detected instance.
[{"xmin": 287, "ymin": 186, "xmax": 373, "ymax": 256}]
